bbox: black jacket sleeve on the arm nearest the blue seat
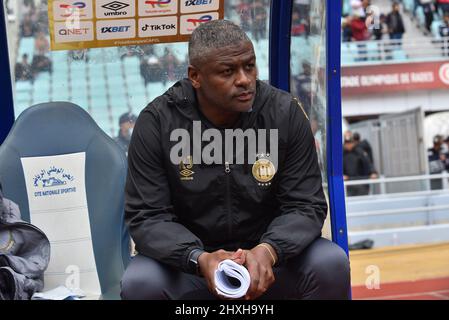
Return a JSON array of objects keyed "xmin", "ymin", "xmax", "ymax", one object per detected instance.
[{"xmin": 125, "ymin": 108, "xmax": 203, "ymax": 272}]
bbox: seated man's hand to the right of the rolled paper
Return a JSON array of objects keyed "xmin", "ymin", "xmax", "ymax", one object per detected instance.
[{"xmin": 244, "ymin": 244, "xmax": 277, "ymax": 300}]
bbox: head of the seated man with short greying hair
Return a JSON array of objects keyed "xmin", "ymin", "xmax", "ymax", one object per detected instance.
[{"xmin": 188, "ymin": 20, "xmax": 257, "ymax": 112}]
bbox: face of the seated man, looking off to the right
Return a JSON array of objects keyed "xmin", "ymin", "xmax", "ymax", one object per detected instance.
[{"xmin": 189, "ymin": 42, "xmax": 257, "ymax": 112}]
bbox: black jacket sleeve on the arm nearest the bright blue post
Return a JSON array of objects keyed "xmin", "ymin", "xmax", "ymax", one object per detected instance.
[{"xmin": 260, "ymin": 102, "xmax": 327, "ymax": 264}]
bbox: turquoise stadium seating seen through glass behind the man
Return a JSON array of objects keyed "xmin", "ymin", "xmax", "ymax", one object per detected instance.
[{"xmin": 15, "ymin": 37, "xmax": 272, "ymax": 136}]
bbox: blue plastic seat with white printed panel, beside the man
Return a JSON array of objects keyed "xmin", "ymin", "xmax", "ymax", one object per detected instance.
[{"xmin": 0, "ymin": 103, "xmax": 130, "ymax": 299}]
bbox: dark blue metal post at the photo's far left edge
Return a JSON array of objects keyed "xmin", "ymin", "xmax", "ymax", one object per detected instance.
[{"xmin": 0, "ymin": 0, "xmax": 14, "ymax": 144}]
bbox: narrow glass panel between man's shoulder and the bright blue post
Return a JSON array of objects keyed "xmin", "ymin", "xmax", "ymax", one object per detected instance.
[{"xmin": 290, "ymin": 0, "xmax": 330, "ymax": 237}]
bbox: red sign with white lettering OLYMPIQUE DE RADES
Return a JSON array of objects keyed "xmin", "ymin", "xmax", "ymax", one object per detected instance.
[{"xmin": 341, "ymin": 61, "xmax": 449, "ymax": 96}]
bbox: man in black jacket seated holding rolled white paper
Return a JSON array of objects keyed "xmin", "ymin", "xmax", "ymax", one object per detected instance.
[{"xmin": 121, "ymin": 20, "xmax": 350, "ymax": 300}]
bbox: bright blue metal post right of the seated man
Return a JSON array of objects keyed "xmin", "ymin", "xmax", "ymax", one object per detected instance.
[{"xmin": 326, "ymin": 0, "xmax": 348, "ymax": 253}]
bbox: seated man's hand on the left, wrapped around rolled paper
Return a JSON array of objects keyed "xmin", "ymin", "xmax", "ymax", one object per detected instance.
[{"xmin": 198, "ymin": 249, "xmax": 245, "ymax": 299}]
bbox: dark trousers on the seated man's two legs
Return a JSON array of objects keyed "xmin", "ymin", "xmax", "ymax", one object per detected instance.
[{"xmin": 121, "ymin": 238, "xmax": 350, "ymax": 300}]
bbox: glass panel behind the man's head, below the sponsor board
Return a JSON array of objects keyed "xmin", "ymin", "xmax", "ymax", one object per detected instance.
[{"xmin": 8, "ymin": 0, "xmax": 270, "ymax": 136}]
